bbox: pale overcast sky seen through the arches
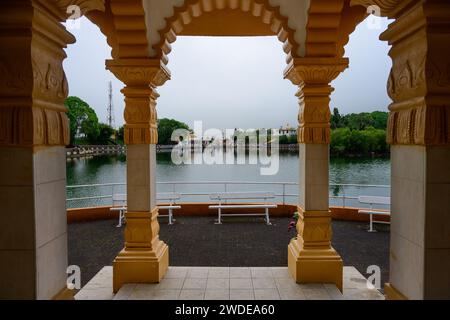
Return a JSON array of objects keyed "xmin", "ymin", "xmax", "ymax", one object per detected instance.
[{"xmin": 65, "ymin": 18, "xmax": 391, "ymax": 129}]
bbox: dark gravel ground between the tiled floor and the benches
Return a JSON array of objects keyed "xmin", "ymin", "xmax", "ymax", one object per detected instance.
[{"xmin": 69, "ymin": 217, "xmax": 389, "ymax": 285}]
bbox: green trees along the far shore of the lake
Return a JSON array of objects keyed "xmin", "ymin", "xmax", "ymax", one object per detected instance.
[{"xmin": 65, "ymin": 97, "xmax": 389, "ymax": 156}]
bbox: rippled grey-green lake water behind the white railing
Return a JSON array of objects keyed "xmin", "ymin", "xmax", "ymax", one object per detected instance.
[{"xmin": 67, "ymin": 152, "xmax": 390, "ymax": 208}]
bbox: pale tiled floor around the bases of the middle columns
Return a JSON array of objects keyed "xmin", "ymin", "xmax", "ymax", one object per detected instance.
[{"xmin": 75, "ymin": 267, "xmax": 384, "ymax": 300}]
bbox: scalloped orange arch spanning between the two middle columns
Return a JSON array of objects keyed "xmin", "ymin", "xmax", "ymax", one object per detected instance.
[{"xmin": 153, "ymin": 0, "xmax": 299, "ymax": 64}]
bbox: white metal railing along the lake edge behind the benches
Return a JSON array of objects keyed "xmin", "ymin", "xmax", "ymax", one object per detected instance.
[{"xmin": 67, "ymin": 181, "xmax": 390, "ymax": 207}]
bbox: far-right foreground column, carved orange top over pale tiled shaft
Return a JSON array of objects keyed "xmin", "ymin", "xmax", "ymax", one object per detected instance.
[{"xmin": 381, "ymin": 1, "xmax": 450, "ymax": 299}]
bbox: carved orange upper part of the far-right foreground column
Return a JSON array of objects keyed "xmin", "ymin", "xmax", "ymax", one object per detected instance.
[{"xmin": 381, "ymin": 1, "xmax": 450, "ymax": 146}]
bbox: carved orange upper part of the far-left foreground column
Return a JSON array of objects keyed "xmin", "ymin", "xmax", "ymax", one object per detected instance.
[{"xmin": 0, "ymin": 0, "xmax": 75, "ymax": 147}]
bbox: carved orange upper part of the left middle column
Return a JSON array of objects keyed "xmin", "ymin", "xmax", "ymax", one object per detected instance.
[{"xmin": 106, "ymin": 59, "xmax": 170, "ymax": 145}]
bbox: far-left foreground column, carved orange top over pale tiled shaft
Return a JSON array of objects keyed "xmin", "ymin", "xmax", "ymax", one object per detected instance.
[{"xmin": 0, "ymin": 0, "xmax": 75, "ymax": 299}]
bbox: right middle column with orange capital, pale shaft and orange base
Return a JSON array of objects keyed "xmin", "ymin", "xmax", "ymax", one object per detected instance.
[{"xmin": 286, "ymin": 58, "xmax": 348, "ymax": 291}]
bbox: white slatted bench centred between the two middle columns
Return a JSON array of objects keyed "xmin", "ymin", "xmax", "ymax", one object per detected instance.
[{"xmin": 209, "ymin": 192, "xmax": 278, "ymax": 225}]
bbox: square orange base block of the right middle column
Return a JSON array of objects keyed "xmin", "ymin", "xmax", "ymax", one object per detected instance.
[{"xmin": 288, "ymin": 239, "xmax": 344, "ymax": 292}]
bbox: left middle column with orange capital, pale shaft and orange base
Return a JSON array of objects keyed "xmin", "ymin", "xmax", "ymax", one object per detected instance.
[{"xmin": 107, "ymin": 59, "xmax": 170, "ymax": 292}]
